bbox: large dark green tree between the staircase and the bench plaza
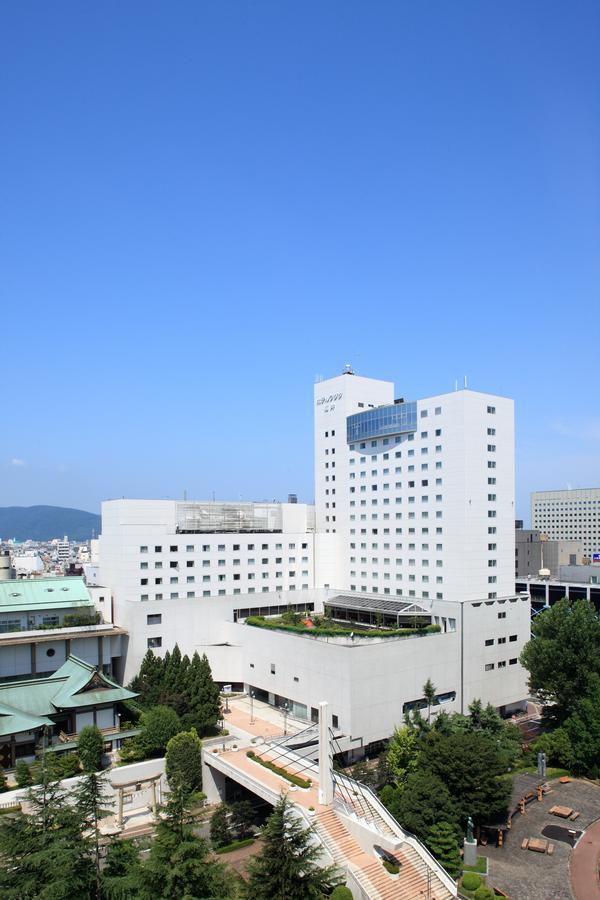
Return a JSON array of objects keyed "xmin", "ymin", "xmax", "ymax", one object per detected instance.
[{"xmin": 419, "ymin": 731, "xmax": 511, "ymax": 823}]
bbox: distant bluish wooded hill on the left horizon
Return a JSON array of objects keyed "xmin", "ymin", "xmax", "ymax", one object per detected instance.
[{"xmin": 0, "ymin": 506, "xmax": 100, "ymax": 541}]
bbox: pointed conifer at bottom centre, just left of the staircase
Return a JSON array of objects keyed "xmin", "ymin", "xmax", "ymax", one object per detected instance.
[{"xmin": 247, "ymin": 795, "xmax": 341, "ymax": 900}]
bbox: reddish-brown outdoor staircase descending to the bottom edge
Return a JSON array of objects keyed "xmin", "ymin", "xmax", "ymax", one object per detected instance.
[{"xmin": 316, "ymin": 809, "xmax": 452, "ymax": 900}]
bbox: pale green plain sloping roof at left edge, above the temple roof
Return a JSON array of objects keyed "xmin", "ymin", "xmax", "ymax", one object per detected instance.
[{"xmin": 0, "ymin": 577, "xmax": 94, "ymax": 613}]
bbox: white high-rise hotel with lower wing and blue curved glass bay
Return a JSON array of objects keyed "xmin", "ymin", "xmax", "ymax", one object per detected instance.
[{"xmin": 99, "ymin": 372, "xmax": 530, "ymax": 753}]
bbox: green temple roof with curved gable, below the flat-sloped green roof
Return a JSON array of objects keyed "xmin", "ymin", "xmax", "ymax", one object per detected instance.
[{"xmin": 0, "ymin": 656, "xmax": 137, "ymax": 737}]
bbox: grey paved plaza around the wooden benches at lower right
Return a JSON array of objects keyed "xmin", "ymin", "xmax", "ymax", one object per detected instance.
[{"xmin": 478, "ymin": 780, "xmax": 600, "ymax": 900}]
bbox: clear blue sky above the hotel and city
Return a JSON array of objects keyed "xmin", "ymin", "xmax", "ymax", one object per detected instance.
[{"xmin": 0, "ymin": 0, "xmax": 600, "ymax": 517}]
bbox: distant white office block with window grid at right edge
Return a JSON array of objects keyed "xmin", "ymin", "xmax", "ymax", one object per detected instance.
[{"xmin": 531, "ymin": 488, "xmax": 600, "ymax": 563}]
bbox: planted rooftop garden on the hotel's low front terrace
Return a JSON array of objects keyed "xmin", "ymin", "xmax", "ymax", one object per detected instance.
[{"xmin": 246, "ymin": 611, "xmax": 440, "ymax": 638}]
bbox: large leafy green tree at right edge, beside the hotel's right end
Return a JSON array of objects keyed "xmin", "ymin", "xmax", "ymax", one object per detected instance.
[{"xmin": 521, "ymin": 600, "xmax": 600, "ymax": 725}]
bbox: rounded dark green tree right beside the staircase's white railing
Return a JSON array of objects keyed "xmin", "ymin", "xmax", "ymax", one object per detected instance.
[{"xmin": 380, "ymin": 769, "xmax": 458, "ymax": 841}]
